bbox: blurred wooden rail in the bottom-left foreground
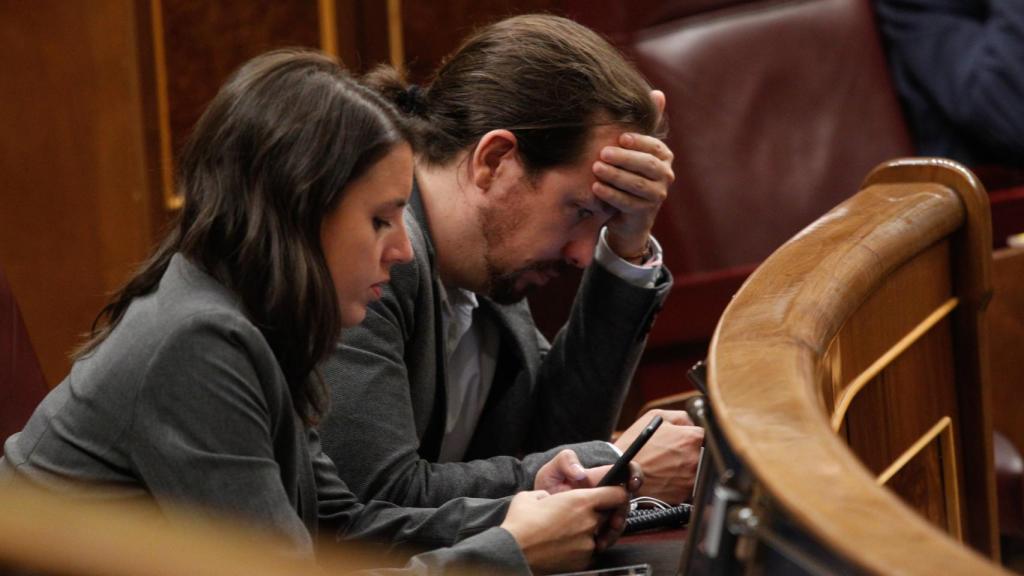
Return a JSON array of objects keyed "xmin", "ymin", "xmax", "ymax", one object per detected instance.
[{"xmin": 0, "ymin": 479, "xmax": 415, "ymax": 576}]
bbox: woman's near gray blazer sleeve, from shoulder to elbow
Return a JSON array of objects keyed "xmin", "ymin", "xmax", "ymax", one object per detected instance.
[{"xmin": 123, "ymin": 315, "xmax": 312, "ymax": 551}]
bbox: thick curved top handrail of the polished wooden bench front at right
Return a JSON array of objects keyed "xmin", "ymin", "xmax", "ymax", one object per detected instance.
[{"xmin": 708, "ymin": 159, "xmax": 1001, "ymax": 575}]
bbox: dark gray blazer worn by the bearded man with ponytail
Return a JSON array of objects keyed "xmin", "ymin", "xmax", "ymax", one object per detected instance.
[{"xmin": 319, "ymin": 190, "xmax": 672, "ymax": 506}]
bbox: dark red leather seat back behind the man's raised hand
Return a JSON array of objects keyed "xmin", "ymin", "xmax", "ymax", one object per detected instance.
[{"xmin": 585, "ymin": 0, "xmax": 912, "ymax": 276}]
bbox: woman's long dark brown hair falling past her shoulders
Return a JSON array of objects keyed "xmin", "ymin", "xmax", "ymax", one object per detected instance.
[{"xmin": 75, "ymin": 50, "xmax": 408, "ymax": 424}]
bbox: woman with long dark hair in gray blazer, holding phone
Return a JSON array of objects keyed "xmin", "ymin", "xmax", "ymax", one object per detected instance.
[{"xmin": 0, "ymin": 50, "xmax": 627, "ymax": 571}]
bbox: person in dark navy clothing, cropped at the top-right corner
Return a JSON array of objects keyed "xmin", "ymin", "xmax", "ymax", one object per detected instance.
[{"xmin": 876, "ymin": 0, "xmax": 1024, "ymax": 167}]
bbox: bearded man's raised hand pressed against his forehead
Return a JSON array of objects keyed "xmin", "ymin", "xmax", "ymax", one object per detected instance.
[{"xmin": 593, "ymin": 90, "xmax": 676, "ymax": 259}]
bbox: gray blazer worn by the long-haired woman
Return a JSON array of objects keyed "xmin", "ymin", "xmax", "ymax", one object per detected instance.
[{"xmin": 0, "ymin": 254, "xmax": 528, "ymax": 573}]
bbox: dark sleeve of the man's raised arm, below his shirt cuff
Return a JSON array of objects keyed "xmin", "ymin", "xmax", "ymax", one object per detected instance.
[{"xmin": 530, "ymin": 263, "xmax": 672, "ymax": 450}]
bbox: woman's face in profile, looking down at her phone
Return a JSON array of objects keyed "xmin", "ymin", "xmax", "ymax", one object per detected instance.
[{"xmin": 321, "ymin": 143, "xmax": 413, "ymax": 327}]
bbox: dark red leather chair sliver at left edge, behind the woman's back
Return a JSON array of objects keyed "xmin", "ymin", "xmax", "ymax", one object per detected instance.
[{"xmin": 0, "ymin": 269, "xmax": 48, "ymax": 438}]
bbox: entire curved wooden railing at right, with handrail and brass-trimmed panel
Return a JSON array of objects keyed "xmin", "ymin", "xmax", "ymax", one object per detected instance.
[{"xmin": 691, "ymin": 159, "xmax": 999, "ymax": 574}]
